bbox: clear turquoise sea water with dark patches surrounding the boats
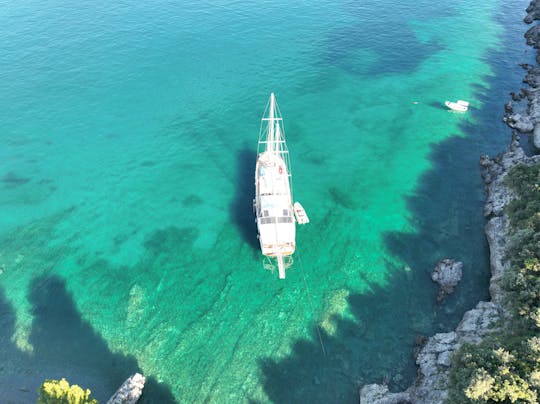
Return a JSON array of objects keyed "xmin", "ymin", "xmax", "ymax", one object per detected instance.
[{"xmin": 0, "ymin": 0, "xmax": 530, "ymax": 402}]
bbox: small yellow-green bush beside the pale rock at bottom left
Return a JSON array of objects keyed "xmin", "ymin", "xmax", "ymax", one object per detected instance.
[{"xmin": 37, "ymin": 379, "xmax": 98, "ymax": 404}]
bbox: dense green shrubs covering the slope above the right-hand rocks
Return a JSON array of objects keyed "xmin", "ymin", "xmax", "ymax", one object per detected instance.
[{"xmin": 448, "ymin": 163, "xmax": 540, "ymax": 404}]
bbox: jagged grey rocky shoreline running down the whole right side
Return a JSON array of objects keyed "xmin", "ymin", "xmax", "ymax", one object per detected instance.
[{"xmin": 360, "ymin": 0, "xmax": 540, "ymax": 404}]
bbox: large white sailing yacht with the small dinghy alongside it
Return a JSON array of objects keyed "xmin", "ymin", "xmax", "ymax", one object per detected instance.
[{"xmin": 253, "ymin": 93, "xmax": 309, "ymax": 279}]
